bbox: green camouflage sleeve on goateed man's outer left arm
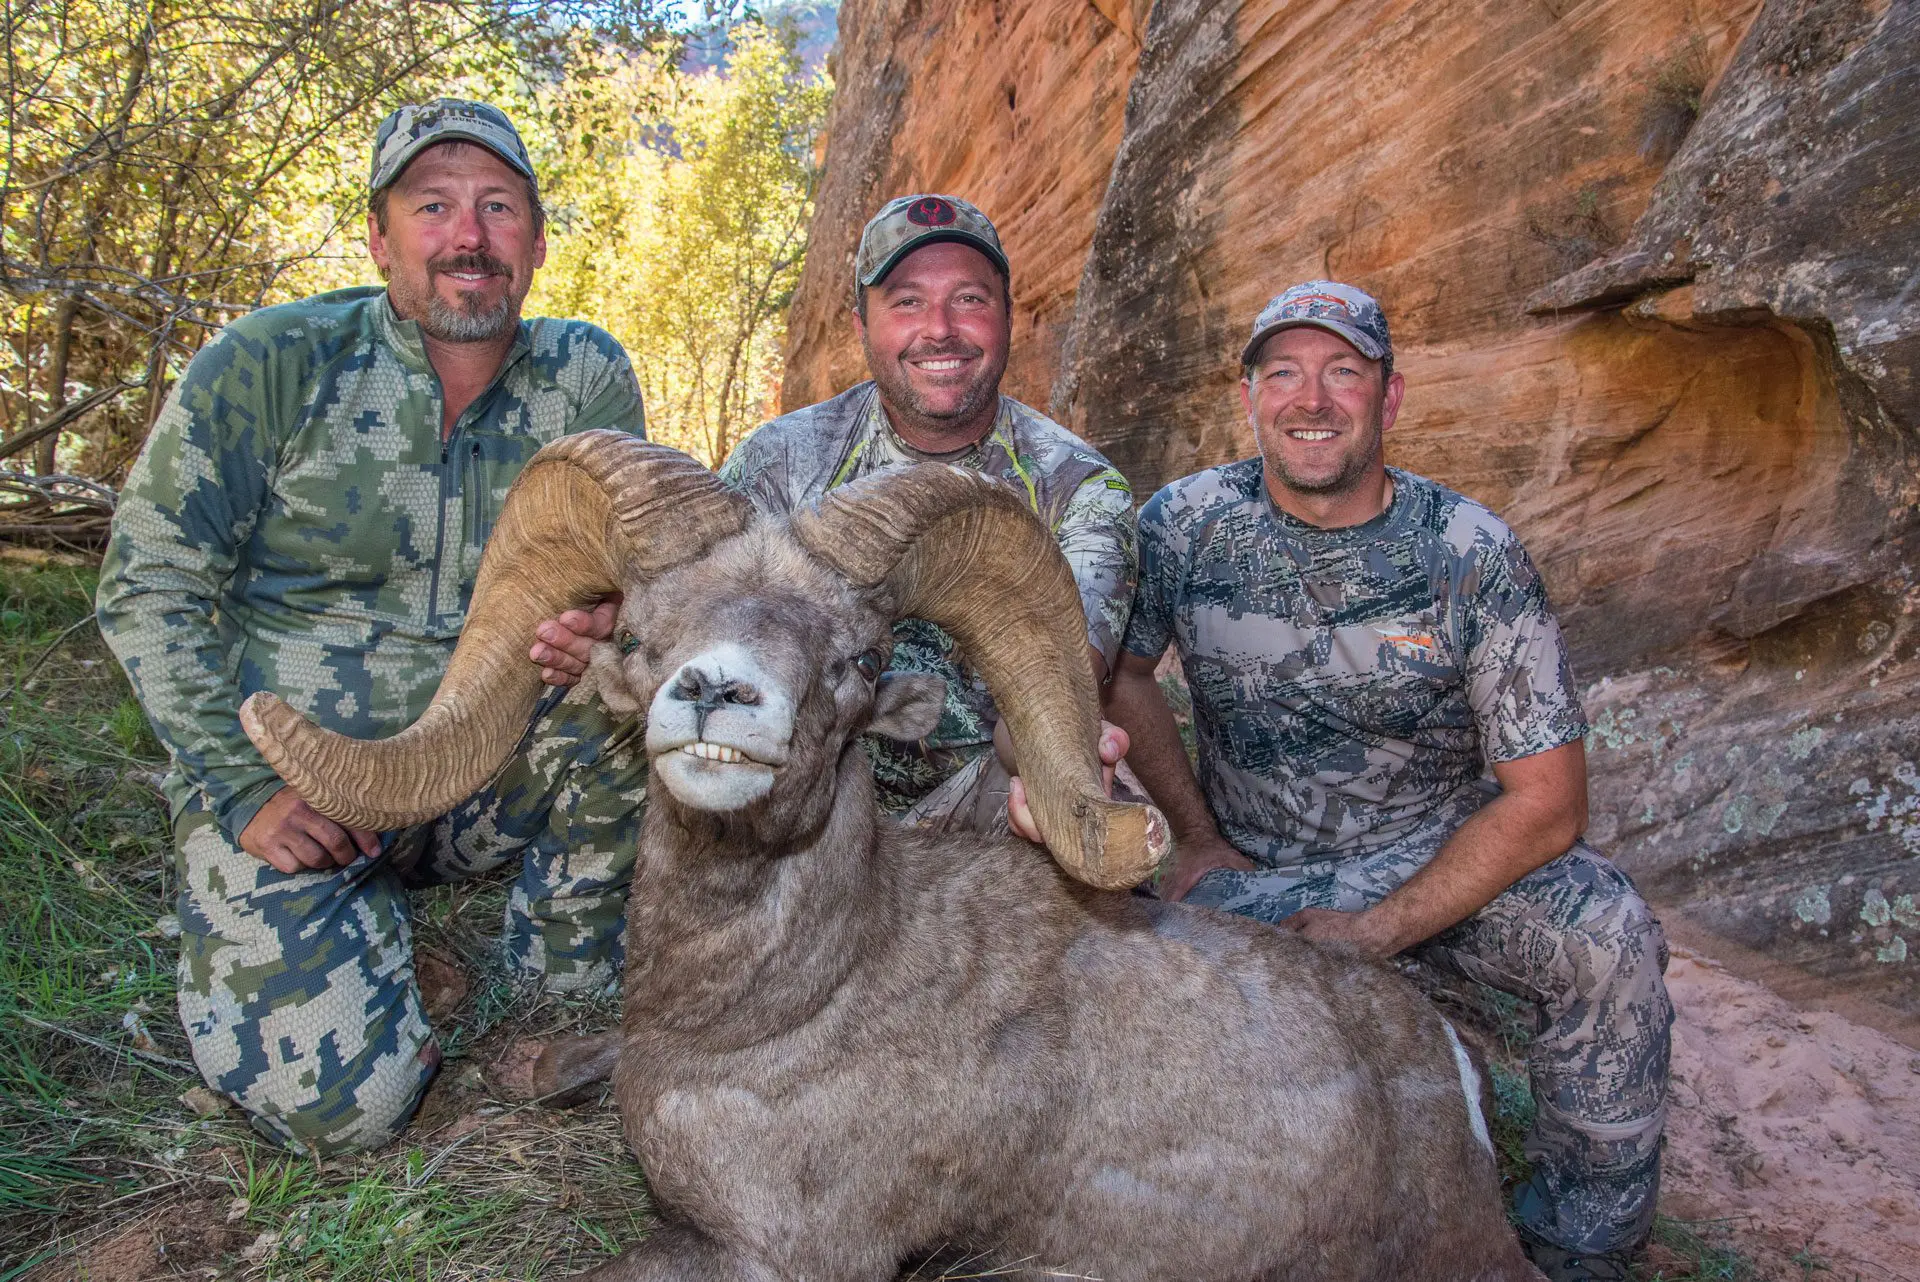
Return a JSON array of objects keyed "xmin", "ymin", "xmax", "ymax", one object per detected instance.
[{"xmin": 96, "ymin": 324, "xmax": 288, "ymax": 839}]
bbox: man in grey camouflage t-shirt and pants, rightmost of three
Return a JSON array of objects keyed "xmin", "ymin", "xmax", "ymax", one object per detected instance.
[{"xmin": 1108, "ymin": 280, "xmax": 1672, "ymax": 1282}]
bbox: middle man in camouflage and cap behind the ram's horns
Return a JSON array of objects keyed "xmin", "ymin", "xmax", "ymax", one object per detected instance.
[{"xmin": 720, "ymin": 196, "xmax": 1135, "ymax": 829}]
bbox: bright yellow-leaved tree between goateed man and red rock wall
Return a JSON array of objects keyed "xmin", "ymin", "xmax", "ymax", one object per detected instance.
[{"xmin": 528, "ymin": 23, "xmax": 831, "ymax": 464}]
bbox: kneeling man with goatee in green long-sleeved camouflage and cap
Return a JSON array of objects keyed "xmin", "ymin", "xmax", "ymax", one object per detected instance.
[{"xmin": 98, "ymin": 98, "xmax": 645, "ymax": 1155}]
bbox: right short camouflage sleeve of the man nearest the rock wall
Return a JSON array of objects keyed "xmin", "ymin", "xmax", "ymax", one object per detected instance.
[{"xmin": 1463, "ymin": 532, "xmax": 1588, "ymax": 762}]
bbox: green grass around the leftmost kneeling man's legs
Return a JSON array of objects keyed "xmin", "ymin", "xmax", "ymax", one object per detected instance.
[{"xmin": 0, "ymin": 562, "xmax": 647, "ymax": 1282}]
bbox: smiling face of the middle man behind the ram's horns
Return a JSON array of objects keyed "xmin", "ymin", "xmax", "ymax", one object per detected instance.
[{"xmin": 854, "ymin": 242, "xmax": 1012, "ymax": 453}]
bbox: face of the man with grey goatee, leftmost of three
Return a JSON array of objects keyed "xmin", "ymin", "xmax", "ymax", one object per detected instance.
[{"xmin": 367, "ymin": 142, "xmax": 547, "ymax": 344}]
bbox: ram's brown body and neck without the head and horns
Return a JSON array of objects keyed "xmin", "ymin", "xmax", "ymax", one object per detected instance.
[{"xmin": 614, "ymin": 794, "xmax": 1532, "ymax": 1282}]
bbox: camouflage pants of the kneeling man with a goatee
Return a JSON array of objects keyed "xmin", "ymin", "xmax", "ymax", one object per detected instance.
[{"xmin": 173, "ymin": 697, "xmax": 647, "ymax": 1155}]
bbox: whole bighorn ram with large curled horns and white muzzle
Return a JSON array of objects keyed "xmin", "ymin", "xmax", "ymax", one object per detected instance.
[{"xmin": 242, "ymin": 432, "xmax": 1540, "ymax": 1282}]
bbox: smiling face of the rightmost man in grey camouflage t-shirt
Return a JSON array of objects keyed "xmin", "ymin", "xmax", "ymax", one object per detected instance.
[{"xmin": 1240, "ymin": 324, "xmax": 1405, "ymax": 524}]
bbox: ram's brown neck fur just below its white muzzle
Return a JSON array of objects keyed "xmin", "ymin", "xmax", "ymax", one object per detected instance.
[{"xmin": 626, "ymin": 743, "xmax": 889, "ymax": 1050}]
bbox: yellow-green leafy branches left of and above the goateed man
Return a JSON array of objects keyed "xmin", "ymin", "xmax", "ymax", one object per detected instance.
[{"xmin": 0, "ymin": 0, "xmax": 668, "ymax": 478}]
